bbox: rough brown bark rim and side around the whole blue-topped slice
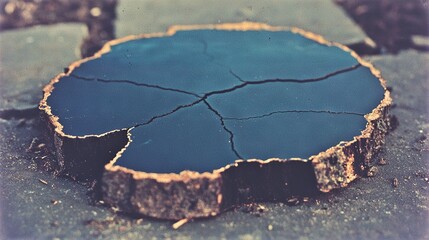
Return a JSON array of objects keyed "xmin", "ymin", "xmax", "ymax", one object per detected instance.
[{"xmin": 40, "ymin": 22, "xmax": 392, "ymax": 219}]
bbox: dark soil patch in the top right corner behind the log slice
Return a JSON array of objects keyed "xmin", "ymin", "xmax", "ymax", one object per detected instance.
[{"xmin": 334, "ymin": 0, "xmax": 429, "ymax": 55}]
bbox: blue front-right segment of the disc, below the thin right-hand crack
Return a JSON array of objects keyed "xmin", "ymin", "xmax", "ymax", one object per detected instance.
[{"xmin": 225, "ymin": 112, "xmax": 366, "ymax": 159}]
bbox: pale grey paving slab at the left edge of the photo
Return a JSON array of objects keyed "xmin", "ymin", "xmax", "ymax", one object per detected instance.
[{"xmin": 0, "ymin": 24, "xmax": 87, "ymax": 109}]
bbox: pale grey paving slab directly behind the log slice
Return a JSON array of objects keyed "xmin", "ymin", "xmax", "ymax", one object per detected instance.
[{"xmin": 116, "ymin": 0, "xmax": 365, "ymax": 44}]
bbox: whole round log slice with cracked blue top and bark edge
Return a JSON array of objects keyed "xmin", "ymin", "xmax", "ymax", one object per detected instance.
[{"xmin": 40, "ymin": 22, "xmax": 391, "ymax": 219}]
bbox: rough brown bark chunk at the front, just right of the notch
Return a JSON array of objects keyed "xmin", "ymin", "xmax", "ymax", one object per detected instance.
[{"xmin": 101, "ymin": 128, "xmax": 222, "ymax": 220}]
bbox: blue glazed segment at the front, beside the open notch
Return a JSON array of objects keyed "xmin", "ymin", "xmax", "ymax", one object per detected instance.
[{"xmin": 116, "ymin": 102, "xmax": 237, "ymax": 173}]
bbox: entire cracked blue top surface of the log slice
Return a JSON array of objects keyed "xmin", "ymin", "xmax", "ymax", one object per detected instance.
[{"xmin": 48, "ymin": 30, "xmax": 384, "ymax": 173}]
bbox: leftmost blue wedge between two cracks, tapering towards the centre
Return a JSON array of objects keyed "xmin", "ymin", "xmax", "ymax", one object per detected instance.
[{"xmin": 48, "ymin": 77, "xmax": 195, "ymax": 136}]
